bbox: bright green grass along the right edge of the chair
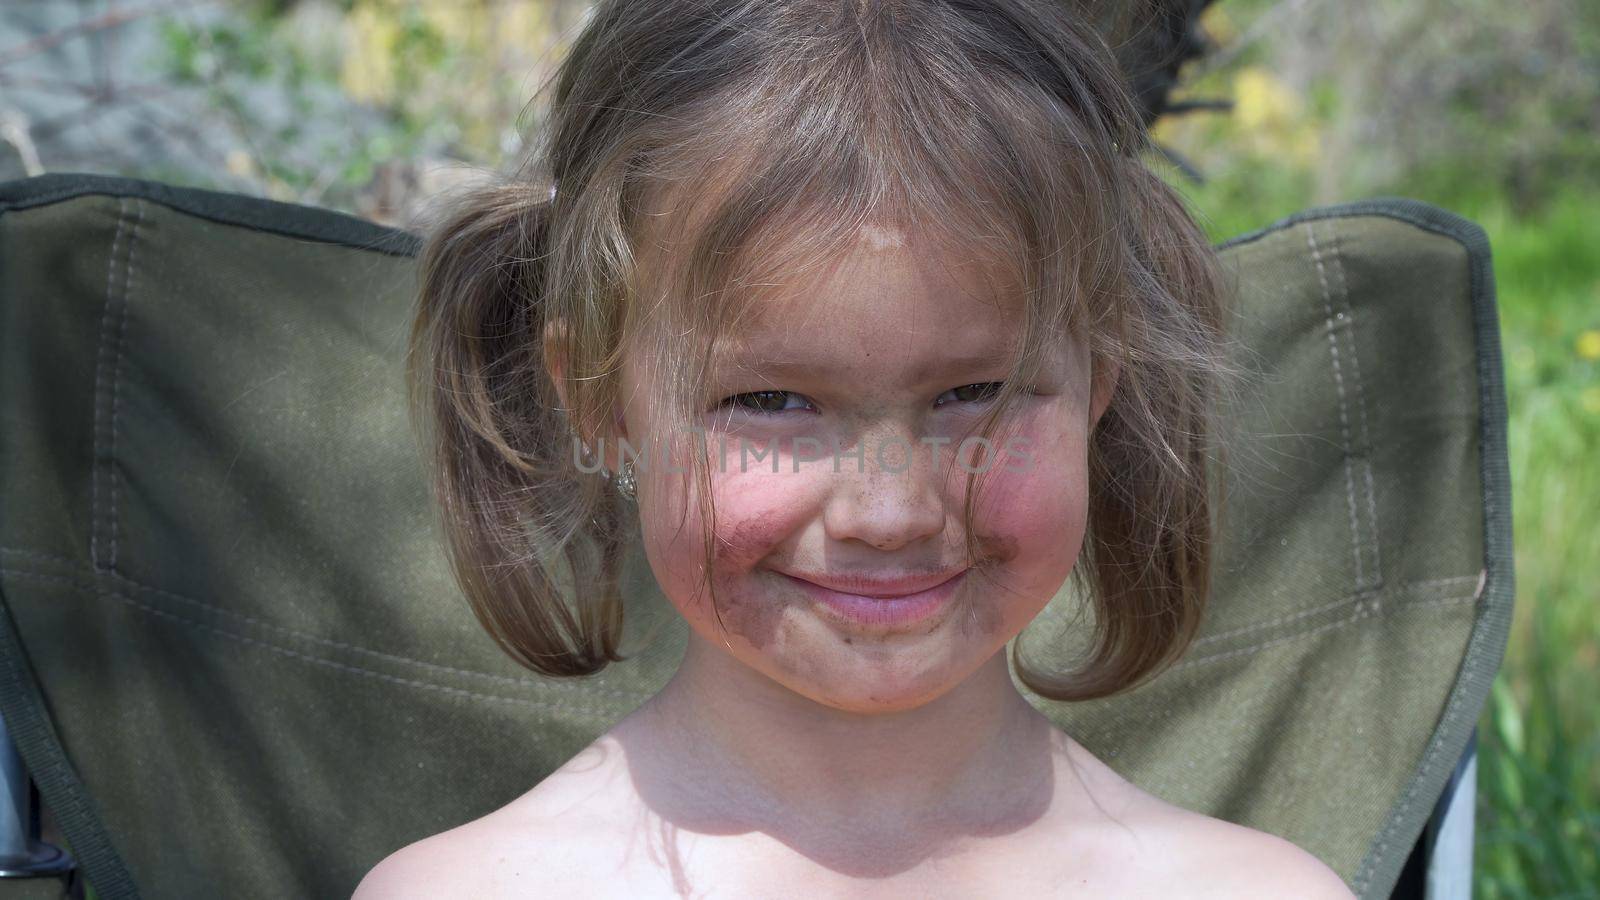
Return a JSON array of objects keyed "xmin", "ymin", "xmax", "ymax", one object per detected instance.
[{"xmin": 1179, "ymin": 160, "xmax": 1600, "ymax": 900}]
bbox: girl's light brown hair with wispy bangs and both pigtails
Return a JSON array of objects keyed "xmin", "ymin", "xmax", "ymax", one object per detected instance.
[{"xmin": 408, "ymin": 0, "xmax": 1227, "ymax": 700}]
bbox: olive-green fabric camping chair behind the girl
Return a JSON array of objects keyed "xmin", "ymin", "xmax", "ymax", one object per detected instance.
[{"xmin": 0, "ymin": 175, "xmax": 1512, "ymax": 900}]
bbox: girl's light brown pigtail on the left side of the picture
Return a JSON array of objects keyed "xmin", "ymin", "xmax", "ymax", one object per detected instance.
[{"xmin": 406, "ymin": 179, "xmax": 626, "ymax": 676}]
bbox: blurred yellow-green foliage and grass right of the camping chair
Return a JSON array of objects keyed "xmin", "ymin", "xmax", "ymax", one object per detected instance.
[{"xmin": 1157, "ymin": 0, "xmax": 1600, "ymax": 900}]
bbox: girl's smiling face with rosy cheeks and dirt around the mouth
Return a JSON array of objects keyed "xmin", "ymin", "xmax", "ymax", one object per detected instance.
[{"xmin": 621, "ymin": 220, "xmax": 1109, "ymax": 711}]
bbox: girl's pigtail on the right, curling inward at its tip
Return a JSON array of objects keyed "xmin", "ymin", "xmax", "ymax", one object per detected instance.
[{"xmin": 1018, "ymin": 160, "xmax": 1232, "ymax": 700}]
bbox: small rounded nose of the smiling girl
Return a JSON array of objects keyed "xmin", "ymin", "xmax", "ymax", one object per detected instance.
[{"xmin": 822, "ymin": 428, "xmax": 949, "ymax": 551}]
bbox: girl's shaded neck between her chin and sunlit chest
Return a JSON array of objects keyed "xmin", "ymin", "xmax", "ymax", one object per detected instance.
[{"xmin": 629, "ymin": 633, "xmax": 1058, "ymax": 847}]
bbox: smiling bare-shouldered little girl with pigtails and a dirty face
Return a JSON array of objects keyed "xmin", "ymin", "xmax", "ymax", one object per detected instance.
[{"xmin": 357, "ymin": 0, "xmax": 1350, "ymax": 898}]
